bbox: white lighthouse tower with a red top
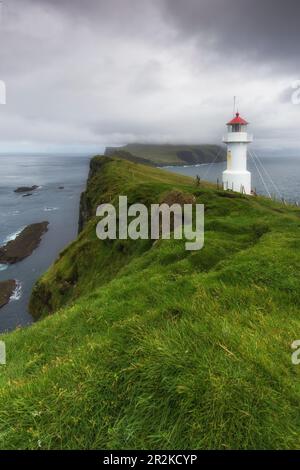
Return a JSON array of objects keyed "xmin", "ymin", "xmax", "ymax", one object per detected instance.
[{"xmin": 223, "ymin": 113, "xmax": 253, "ymax": 194}]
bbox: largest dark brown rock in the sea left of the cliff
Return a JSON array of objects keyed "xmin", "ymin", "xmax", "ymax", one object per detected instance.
[{"xmin": 0, "ymin": 222, "xmax": 49, "ymax": 264}]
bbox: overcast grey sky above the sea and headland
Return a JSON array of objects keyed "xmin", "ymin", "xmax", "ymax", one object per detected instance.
[{"xmin": 0, "ymin": 0, "xmax": 300, "ymax": 155}]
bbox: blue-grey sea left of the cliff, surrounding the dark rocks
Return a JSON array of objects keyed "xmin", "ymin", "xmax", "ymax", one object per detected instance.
[{"xmin": 0, "ymin": 155, "xmax": 90, "ymax": 333}]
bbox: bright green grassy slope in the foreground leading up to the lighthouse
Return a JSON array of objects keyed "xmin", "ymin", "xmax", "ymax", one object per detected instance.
[{"xmin": 0, "ymin": 159, "xmax": 300, "ymax": 449}]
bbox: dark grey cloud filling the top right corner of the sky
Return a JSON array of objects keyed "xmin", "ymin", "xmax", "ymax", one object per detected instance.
[{"xmin": 162, "ymin": 0, "xmax": 300, "ymax": 70}]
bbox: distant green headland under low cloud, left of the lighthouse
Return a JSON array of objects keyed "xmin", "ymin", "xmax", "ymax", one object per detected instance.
[{"xmin": 105, "ymin": 143, "xmax": 226, "ymax": 166}]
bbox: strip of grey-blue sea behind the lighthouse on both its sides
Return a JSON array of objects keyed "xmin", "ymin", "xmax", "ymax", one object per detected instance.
[{"xmin": 165, "ymin": 156, "xmax": 300, "ymax": 205}]
